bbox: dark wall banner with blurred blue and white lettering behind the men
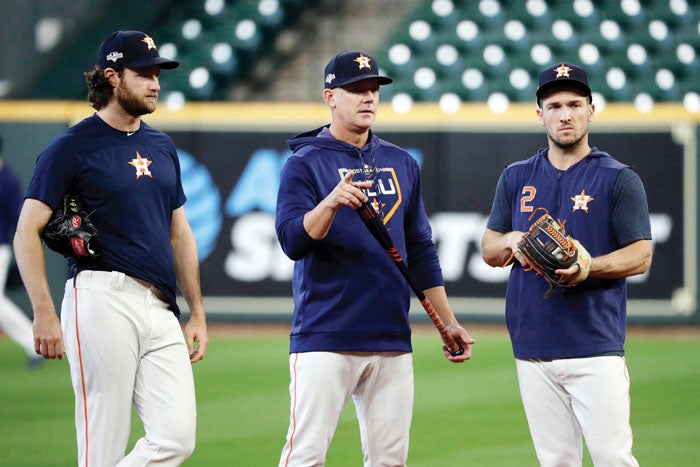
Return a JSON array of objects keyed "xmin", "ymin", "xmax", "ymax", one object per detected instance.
[{"xmin": 168, "ymin": 129, "xmax": 696, "ymax": 322}]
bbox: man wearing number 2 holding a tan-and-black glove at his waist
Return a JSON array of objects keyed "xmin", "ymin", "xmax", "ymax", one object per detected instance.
[{"xmin": 482, "ymin": 63, "xmax": 652, "ymax": 466}]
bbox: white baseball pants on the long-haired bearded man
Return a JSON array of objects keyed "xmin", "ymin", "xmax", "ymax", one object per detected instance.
[{"xmin": 61, "ymin": 271, "xmax": 197, "ymax": 467}]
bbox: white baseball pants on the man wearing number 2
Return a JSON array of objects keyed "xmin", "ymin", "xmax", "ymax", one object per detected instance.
[{"xmin": 516, "ymin": 356, "xmax": 639, "ymax": 467}]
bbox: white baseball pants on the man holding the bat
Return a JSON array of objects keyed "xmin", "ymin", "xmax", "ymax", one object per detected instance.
[{"xmin": 279, "ymin": 352, "xmax": 413, "ymax": 467}]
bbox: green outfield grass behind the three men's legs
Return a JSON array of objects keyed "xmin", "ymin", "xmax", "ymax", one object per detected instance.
[{"xmin": 0, "ymin": 327, "xmax": 700, "ymax": 467}]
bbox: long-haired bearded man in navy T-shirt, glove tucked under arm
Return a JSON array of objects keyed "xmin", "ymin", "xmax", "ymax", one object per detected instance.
[{"xmin": 14, "ymin": 30, "xmax": 208, "ymax": 466}]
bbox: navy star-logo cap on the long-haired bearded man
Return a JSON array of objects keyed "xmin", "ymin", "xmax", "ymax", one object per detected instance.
[{"xmin": 97, "ymin": 30, "xmax": 180, "ymax": 70}]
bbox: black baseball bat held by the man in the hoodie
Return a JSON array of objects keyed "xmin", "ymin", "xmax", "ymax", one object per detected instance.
[{"xmin": 357, "ymin": 202, "xmax": 464, "ymax": 357}]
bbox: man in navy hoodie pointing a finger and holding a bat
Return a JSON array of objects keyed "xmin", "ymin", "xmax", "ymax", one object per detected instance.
[{"xmin": 276, "ymin": 51, "xmax": 474, "ymax": 466}]
